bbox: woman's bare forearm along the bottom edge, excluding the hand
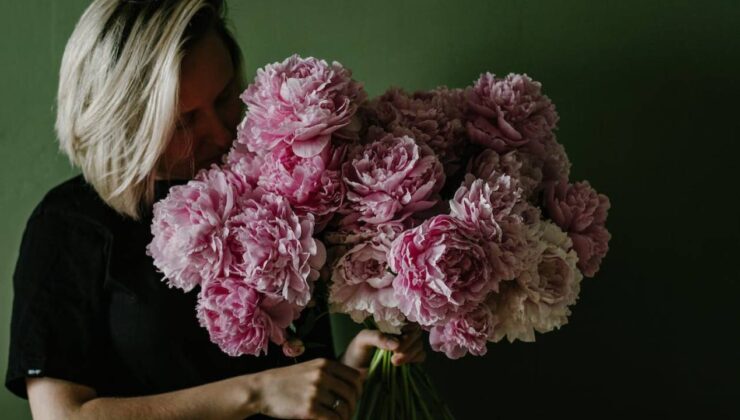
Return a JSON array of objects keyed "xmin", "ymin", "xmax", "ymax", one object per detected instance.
[{"xmin": 75, "ymin": 375, "xmax": 260, "ymax": 420}]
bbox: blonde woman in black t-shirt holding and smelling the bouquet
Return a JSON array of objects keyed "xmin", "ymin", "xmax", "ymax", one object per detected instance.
[{"xmin": 6, "ymin": 0, "xmax": 425, "ymax": 419}]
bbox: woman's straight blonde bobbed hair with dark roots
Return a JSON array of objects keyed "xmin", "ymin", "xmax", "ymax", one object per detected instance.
[{"xmin": 55, "ymin": 0, "xmax": 241, "ymax": 219}]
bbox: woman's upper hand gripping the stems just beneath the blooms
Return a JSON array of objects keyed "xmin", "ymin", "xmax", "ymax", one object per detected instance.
[{"xmin": 342, "ymin": 324, "xmax": 426, "ymax": 370}]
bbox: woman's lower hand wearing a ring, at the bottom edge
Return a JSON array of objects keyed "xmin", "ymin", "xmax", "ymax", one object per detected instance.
[{"xmin": 250, "ymin": 359, "xmax": 364, "ymax": 420}]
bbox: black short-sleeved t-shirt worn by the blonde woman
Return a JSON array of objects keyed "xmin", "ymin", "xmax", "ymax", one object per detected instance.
[{"xmin": 5, "ymin": 176, "xmax": 334, "ymax": 414}]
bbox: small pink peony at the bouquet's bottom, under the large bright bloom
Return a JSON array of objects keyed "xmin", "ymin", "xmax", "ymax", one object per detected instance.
[{"xmin": 429, "ymin": 304, "xmax": 495, "ymax": 359}]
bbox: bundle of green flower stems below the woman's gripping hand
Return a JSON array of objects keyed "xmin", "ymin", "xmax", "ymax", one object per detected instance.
[{"xmin": 353, "ymin": 349, "xmax": 454, "ymax": 420}]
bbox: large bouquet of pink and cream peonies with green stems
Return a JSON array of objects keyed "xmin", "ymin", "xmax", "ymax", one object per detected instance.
[{"xmin": 148, "ymin": 55, "xmax": 610, "ymax": 418}]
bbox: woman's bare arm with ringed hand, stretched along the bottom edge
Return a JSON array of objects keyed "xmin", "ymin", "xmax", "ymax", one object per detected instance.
[{"xmin": 27, "ymin": 359, "xmax": 364, "ymax": 420}]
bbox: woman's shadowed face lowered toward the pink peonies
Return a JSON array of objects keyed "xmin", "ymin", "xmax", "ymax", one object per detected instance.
[{"xmin": 157, "ymin": 30, "xmax": 242, "ymax": 179}]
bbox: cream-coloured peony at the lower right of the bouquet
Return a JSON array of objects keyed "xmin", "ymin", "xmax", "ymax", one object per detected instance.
[{"xmin": 488, "ymin": 220, "xmax": 583, "ymax": 342}]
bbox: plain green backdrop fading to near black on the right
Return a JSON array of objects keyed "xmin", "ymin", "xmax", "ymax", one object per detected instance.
[{"xmin": 0, "ymin": 0, "xmax": 740, "ymax": 419}]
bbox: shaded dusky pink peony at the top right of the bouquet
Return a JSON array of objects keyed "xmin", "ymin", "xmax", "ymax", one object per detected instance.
[{"xmin": 466, "ymin": 73, "xmax": 559, "ymax": 153}]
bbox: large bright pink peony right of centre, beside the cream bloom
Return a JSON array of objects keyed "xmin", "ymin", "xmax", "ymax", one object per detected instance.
[{"xmin": 388, "ymin": 215, "xmax": 498, "ymax": 326}]
